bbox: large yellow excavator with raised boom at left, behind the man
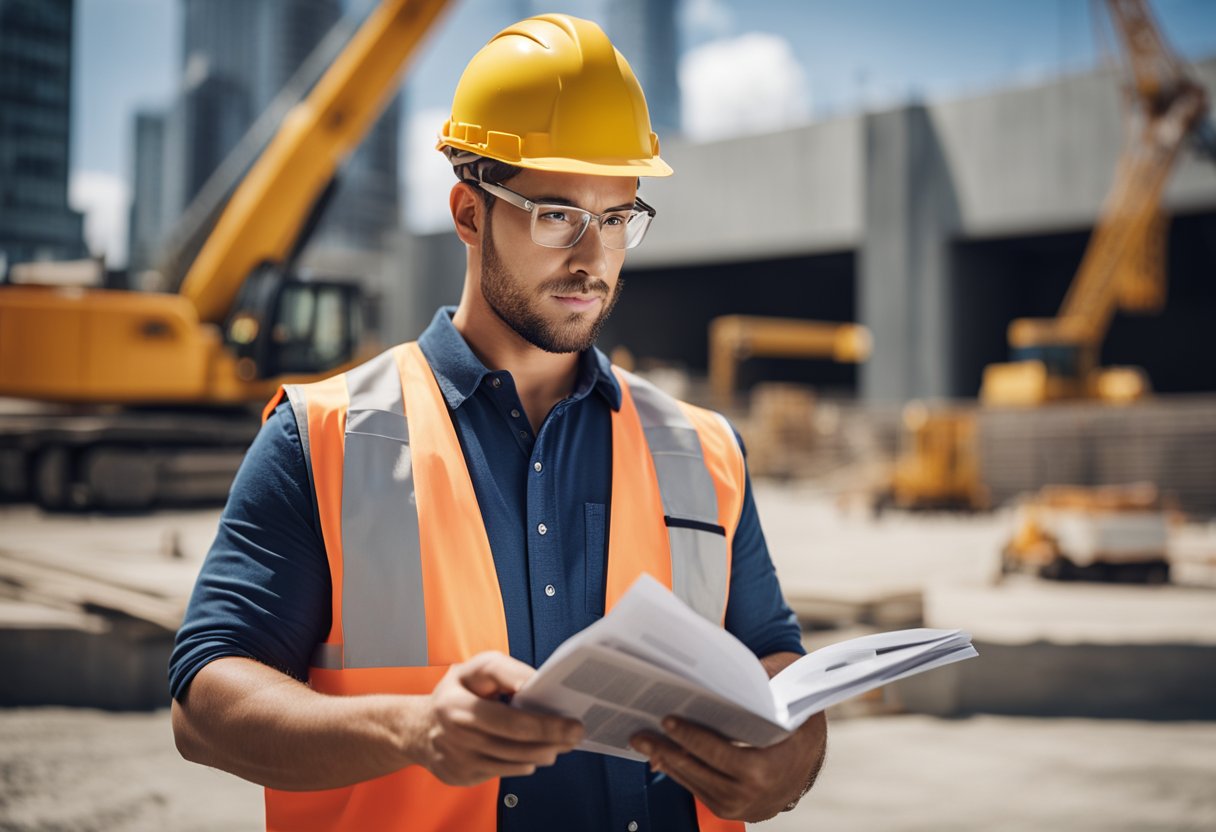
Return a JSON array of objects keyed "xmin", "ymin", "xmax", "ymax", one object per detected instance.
[{"xmin": 0, "ymin": 0, "xmax": 447, "ymax": 507}]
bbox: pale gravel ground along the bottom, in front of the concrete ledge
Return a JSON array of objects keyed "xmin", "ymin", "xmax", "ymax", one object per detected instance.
[{"xmin": 0, "ymin": 709, "xmax": 1216, "ymax": 832}]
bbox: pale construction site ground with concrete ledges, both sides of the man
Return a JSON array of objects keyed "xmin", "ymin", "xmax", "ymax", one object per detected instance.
[{"xmin": 0, "ymin": 480, "xmax": 1216, "ymax": 832}]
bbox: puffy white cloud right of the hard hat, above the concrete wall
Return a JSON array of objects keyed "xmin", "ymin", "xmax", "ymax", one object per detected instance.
[{"xmin": 680, "ymin": 32, "xmax": 811, "ymax": 141}]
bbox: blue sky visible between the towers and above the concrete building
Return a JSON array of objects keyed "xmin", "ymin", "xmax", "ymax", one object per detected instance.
[{"xmin": 72, "ymin": 0, "xmax": 1216, "ymax": 262}]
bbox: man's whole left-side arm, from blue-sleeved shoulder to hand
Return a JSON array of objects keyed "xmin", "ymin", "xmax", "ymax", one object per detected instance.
[{"xmin": 170, "ymin": 405, "xmax": 580, "ymax": 789}]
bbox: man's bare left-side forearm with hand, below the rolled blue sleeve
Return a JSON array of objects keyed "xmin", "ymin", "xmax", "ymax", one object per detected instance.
[{"xmin": 173, "ymin": 653, "xmax": 582, "ymax": 791}]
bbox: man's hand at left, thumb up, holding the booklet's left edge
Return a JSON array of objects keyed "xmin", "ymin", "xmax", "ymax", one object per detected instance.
[{"xmin": 418, "ymin": 653, "xmax": 582, "ymax": 786}]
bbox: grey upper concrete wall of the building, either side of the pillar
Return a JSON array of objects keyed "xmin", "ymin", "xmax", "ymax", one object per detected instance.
[{"xmin": 617, "ymin": 60, "xmax": 1216, "ymax": 268}]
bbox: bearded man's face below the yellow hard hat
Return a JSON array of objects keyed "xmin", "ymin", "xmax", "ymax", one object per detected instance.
[{"xmin": 482, "ymin": 170, "xmax": 637, "ymax": 353}]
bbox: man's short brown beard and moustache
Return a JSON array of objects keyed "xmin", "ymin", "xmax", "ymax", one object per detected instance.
[{"xmin": 482, "ymin": 224, "xmax": 625, "ymax": 353}]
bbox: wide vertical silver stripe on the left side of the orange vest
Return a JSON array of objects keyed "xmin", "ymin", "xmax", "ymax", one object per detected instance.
[{"xmin": 342, "ymin": 352, "xmax": 427, "ymax": 668}]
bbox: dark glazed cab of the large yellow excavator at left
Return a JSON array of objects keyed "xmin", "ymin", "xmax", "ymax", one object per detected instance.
[{"xmin": 224, "ymin": 264, "xmax": 367, "ymax": 381}]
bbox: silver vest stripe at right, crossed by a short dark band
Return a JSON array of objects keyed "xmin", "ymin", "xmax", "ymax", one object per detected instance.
[{"xmin": 624, "ymin": 372, "xmax": 727, "ymax": 624}]
